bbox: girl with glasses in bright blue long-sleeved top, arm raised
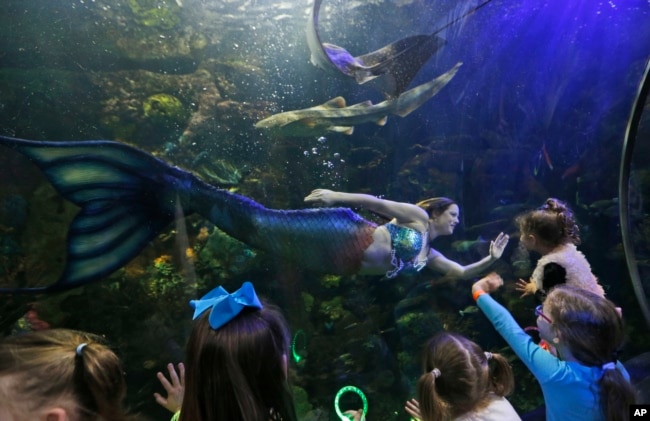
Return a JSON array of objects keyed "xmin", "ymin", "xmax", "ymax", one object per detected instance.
[{"xmin": 472, "ymin": 273, "xmax": 635, "ymax": 421}]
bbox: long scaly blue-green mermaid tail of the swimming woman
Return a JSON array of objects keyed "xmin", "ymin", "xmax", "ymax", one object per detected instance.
[{"xmin": 0, "ymin": 136, "xmax": 376, "ymax": 293}]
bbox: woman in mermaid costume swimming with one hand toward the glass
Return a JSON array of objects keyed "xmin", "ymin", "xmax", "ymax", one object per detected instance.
[{"xmin": 0, "ymin": 136, "xmax": 508, "ymax": 293}]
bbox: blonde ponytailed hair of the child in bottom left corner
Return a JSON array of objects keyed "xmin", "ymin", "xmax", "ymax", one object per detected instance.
[{"xmin": 0, "ymin": 329, "xmax": 129, "ymax": 421}]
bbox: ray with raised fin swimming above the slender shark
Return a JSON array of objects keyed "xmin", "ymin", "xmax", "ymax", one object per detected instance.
[{"xmin": 305, "ymin": 0, "xmax": 446, "ymax": 98}]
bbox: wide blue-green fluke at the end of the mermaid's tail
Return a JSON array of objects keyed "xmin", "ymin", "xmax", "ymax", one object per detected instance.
[{"xmin": 0, "ymin": 136, "xmax": 176, "ymax": 293}]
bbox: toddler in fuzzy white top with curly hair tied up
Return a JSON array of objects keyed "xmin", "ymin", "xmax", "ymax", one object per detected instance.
[{"xmin": 515, "ymin": 198, "xmax": 605, "ymax": 300}]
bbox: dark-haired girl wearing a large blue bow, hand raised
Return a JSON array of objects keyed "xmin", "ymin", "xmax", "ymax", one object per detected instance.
[{"xmin": 155, "ymin": 282, "xmax": 296, "ymax": 421}]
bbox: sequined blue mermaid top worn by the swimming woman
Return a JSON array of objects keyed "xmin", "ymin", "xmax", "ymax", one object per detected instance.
[{"xmin": 385, "ymin": 223, "xmax": 427, "ymax": 279}]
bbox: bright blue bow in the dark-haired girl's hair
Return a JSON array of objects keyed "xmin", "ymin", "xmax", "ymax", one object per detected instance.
[{"xmin": 190, "ymin": 281, "xmax": 262, "ymax": 330}]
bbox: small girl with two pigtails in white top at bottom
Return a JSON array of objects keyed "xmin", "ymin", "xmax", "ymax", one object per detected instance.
[{"xmin": 406, "ymin": 332, "xmax": 520, "ymax": 421}]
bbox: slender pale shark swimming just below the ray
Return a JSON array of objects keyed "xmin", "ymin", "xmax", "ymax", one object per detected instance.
[{"xmin": 255, "ymin": 62, "xmax": 462, "ymax": 137}]
